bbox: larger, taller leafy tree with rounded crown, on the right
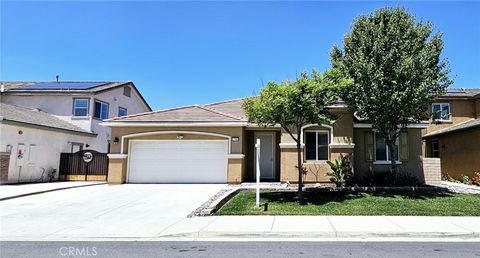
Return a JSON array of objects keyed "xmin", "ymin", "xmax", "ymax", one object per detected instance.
[{"xmin": 331, "ymin": 7, "xmax": 452, "ymax": 175}]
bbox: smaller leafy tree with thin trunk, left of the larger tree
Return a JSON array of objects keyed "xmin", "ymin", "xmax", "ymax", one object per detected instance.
[{"xmin": 242, "ymin": 69, "xmax": 349, "ymax": 200}]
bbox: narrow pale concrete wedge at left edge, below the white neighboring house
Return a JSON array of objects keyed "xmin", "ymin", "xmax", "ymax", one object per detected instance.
[{"xmin": 0, "ymin": 181, "xmax": 106, "ymax": 201}]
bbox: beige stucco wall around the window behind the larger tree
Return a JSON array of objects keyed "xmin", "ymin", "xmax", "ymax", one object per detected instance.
[{"xmin": 354, "ymin": 128, "xmax": 424, "ymax": 182}]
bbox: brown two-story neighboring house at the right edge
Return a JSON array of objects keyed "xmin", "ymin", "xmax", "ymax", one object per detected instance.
[{"xmin": 423, "ymin": 89, "xmax": 480, "ymax": 179}]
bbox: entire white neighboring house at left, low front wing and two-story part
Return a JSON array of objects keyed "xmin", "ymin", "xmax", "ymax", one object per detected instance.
[{"xmin": 0, "ymin": 82, "xmax": 151, "ymax": 183}]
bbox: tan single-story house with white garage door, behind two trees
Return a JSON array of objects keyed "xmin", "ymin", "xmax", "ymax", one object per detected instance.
[{"xmin": 103, "ymin": 99, "xmax": 428, "ymax": 183}]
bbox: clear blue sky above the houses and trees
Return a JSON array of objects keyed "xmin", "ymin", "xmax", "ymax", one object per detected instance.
[{"xmin": 0, "ymin": 1, "xmax": 480, "ymax": 109}]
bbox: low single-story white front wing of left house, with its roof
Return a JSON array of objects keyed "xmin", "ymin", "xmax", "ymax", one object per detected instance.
[{"xmin": 0, "ymin": 102, "xmax": 97, "ymax": 183}]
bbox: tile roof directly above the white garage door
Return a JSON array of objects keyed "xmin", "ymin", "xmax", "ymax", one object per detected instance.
[{"xmin": 105, "ymin": 105, "xmax": 246, "ymax": 123}]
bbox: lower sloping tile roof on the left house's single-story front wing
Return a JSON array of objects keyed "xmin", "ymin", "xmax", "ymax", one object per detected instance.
[{"xmin": 0, "ymin": 102, "xmax": 96, "ymax": 136}]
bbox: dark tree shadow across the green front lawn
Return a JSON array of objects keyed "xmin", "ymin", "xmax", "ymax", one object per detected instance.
[{"xmin": 262, "ymin": 191, "xmax": 454, "ymax": 205}]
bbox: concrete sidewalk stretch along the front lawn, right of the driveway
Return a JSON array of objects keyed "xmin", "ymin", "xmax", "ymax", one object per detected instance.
[{"xmin": 157, "ymin": 216, "xmax": 480, "ymax": 241}]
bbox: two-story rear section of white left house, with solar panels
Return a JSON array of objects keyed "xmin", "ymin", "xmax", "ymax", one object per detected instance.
[{"xmin": 1, "ymin": 81, "xmax": 151, "ymax": 152}]
